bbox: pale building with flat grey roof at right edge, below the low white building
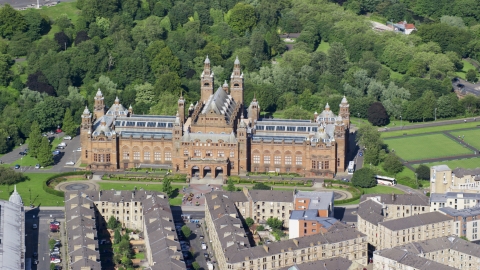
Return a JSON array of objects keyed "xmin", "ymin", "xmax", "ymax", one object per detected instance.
[{"xmin": 438, "ymin": 207, "xmax": 480, "ymax": 241}]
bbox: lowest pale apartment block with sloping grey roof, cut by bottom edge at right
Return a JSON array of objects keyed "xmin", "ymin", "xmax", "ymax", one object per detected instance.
[{"xmin": 373, "ymin": 247, "xmax": 457, "ymax": 270}]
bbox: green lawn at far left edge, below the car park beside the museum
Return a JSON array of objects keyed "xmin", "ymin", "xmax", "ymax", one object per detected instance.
[{"xmin": 0, "ymin": 173, "xmax": 63, "ymax": 206}]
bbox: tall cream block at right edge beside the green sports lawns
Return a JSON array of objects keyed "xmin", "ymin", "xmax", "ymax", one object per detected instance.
[{"xmin": 430, "ymin": 165, "xmax": 480, "ymax": 193}]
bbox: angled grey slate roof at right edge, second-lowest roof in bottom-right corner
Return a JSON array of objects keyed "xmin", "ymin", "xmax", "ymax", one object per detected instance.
[{"xmin": 397, "ymin": 236, "xmax": 480, "ymax": 258}]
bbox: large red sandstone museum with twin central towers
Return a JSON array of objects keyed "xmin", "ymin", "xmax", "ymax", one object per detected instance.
[{"xmin": 80, "ymin": 57, "xmax": 350, "ymax": 180}]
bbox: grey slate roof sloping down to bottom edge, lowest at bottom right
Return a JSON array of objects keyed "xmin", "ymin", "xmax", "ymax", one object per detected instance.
[{"xmin": 374, "ymin": 247, "xmax": 457, "ymax": 270}]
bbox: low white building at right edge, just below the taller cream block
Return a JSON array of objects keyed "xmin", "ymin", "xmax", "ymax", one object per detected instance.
[{"xmin": 430, "ymin": 192, "xmax": 480, "ymax": 212}]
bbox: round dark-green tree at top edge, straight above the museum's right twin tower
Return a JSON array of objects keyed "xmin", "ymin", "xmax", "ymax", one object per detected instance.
[{"xmin": 226, "ymin": 2, "xmax": 257, "ymax": 35}]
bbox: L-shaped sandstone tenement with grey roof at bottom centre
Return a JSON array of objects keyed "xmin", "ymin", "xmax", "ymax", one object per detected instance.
[{"xmin": 205, "ymin": 192, "xmax": 367, "ymax": 270}]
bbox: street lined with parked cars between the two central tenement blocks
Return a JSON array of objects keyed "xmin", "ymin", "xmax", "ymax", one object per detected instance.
[{"xmin": 175, "ymin": 221, "xmax": 214, "ymax": 270}]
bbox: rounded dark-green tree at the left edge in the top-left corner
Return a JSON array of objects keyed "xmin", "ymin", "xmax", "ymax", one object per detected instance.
[{"xmin": 0, "ymin": 4, "xmax": 27, "ymax": 38}]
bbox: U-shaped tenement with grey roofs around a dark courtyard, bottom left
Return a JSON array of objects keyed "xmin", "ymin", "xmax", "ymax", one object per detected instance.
[{"xmin": 65, "ymin": 190, "xmax": 186, "ymax": 270}]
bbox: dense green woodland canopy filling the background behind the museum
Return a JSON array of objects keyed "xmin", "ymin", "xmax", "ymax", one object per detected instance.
[{"xmin": 0, "ymin": 0, "xmax": 480, "ymax": 152}]
